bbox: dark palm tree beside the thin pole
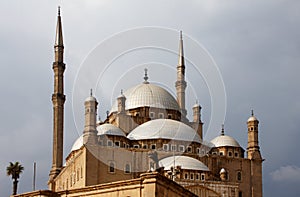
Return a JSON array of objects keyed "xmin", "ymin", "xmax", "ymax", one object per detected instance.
[{"xmin": 6, "ymin": 161, "xmax": 24, "ymax": 195}]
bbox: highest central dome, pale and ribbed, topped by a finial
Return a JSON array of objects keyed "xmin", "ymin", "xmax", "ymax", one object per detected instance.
[{"xmin": 110, "ymin": 83, "xmax": 179, "ymax": 112}]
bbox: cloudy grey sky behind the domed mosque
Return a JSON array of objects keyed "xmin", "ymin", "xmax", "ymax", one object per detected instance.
[{"xmin": 0, "ymin": 0, "xmax": 300, "ymax": 197}]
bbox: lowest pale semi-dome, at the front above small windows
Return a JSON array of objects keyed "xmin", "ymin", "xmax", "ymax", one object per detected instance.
[{"xmin": 159, "ymin": 155, "xmax": 209, "ymax": 171}]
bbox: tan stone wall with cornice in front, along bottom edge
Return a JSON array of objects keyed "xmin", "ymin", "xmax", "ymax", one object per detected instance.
[{"xmin": 15, "ymin": 173, "xmax": 199, "ymax": 197}]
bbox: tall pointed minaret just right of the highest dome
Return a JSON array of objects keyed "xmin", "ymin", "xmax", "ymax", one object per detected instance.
[{"xmin": 175, "ymin": 31, "xmax": 187, "ymax": 120}]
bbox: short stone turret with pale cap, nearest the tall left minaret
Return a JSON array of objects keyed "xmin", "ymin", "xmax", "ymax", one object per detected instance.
[{"xmin": 83, "ymin": 90, "xmax": 98, "ymax": 145}]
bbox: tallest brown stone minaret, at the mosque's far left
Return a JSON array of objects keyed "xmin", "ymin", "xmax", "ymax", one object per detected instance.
[{"xmin": 49, "ymin": 7, "xmax": 66, "ymax": 187}]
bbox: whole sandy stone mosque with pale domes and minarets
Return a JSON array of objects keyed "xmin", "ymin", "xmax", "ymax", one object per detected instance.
[{"xmin": 16, "ymin": 8, "xmax": 263, "ymax": 197}]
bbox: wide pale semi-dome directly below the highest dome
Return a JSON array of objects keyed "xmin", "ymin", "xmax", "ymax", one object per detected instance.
[{"xmin": 127, "ymin": 119, "xmax": 201, "ymax": 143}]
